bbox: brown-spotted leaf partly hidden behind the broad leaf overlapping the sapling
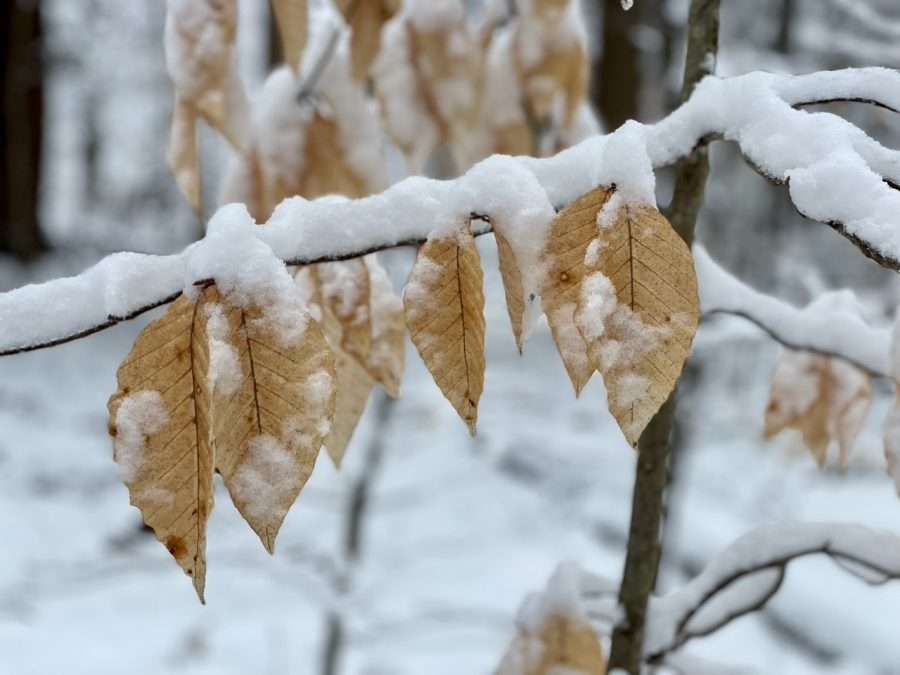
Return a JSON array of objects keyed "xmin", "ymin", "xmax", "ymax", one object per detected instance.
[{"xmin": 541, "ymin": 187, "xmax": 613, "ymax": 396}]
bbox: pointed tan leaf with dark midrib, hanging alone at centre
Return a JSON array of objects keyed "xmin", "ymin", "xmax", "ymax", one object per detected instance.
[{"xmin": 403, "ymin": 224, "xmax": 485, "ymax": 435}]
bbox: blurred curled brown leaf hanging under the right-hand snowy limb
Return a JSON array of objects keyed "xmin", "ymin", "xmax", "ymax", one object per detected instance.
[{"xmin": 764, "ymin": 351, "xmax": 872, "ymax": 468}]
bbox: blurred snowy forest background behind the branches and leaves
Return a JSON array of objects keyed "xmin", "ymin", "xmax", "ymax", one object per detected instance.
[{"xmin": 0, "ymin": 0, "xmax": 900, "ymax": 675}]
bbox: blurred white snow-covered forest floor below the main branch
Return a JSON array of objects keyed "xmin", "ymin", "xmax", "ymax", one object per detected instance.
[{"xmin": 0, "ymin": 244, "xmax": 900, "ymax": 675}]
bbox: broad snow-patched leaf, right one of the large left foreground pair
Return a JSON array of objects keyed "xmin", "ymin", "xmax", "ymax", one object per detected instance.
[{"xmin": 213, "ymin": 302, "xmax": 336, "ymax": 553}]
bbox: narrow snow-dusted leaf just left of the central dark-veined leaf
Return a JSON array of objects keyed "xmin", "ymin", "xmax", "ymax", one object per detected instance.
[{"xmin": 365, "ymin": 255, "xmax": 406, "ymax": 399}]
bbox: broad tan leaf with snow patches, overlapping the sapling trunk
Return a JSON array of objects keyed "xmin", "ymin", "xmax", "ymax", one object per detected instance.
[{"xmin": 576, "ymin": 198, "xmax": 700, "ymax": 445}]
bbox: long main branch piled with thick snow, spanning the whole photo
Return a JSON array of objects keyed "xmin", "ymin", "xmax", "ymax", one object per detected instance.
[{"xmin": 0, "ymin": 68, "xmax": 900, "ymax": 355}]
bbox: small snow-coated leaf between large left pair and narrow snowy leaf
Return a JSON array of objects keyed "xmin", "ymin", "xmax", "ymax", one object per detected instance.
[{"xmin": 314, "ymin": 258, "xmax": 372, "ymax": 365}]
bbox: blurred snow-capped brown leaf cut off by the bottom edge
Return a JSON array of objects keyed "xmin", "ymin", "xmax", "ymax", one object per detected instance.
[{"xmin": 495, "ymin": 614, "xmax": 606, "ymax": 675}]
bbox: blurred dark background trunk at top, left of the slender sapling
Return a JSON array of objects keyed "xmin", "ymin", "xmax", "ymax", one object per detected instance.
[{"xmin": 591, "ymin": 0, "xmax": 646, "ymax": 130}]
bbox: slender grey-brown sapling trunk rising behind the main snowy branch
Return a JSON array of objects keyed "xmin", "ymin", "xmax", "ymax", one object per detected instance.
[{"xmin": 609, "ymin": 0, "xmax": 719, "ymax": 675}]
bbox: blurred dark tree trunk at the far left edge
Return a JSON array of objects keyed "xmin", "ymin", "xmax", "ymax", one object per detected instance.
[{"xmin": 0, "ymin": 0, "xmax": 46, "ymax": 260}]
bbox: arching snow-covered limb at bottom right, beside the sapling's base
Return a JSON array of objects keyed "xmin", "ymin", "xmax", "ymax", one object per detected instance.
[{"xmin": 644, "ymin": 523, "xmax": 900, "ymax": 663}]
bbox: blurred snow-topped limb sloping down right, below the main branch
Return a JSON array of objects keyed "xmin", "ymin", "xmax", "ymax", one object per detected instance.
[{"xmin": 693, "ymin": 244, "xmax": 891, "ymax": 377}]
